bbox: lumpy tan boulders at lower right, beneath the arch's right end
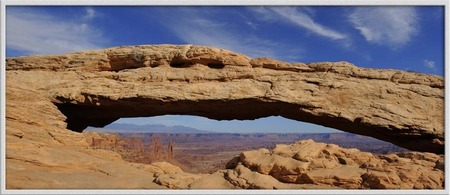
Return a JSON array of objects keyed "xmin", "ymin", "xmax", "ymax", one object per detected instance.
[{"xmin": 227, "ymin": 140, "xmax": 444, "ymax": 189}]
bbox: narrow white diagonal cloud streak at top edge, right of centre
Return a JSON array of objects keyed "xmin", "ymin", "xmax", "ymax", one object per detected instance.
[{"xmin": 250, "ymin": 7, "xmax": 347, "ymax": 40}]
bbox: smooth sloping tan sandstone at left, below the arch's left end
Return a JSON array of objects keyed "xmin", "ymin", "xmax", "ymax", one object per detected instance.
[{"xmin": 5, "ymin": 81, "xmax": 164, "ymax": 189}]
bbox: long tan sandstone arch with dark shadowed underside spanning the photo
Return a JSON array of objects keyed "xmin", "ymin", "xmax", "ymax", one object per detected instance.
[{"xmin": 6, "ymin": 45, "xmax": 445, "ymax": 154}]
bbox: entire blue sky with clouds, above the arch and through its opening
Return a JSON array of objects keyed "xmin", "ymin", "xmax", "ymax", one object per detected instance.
[{"xmin": 6, "ymin": 6, "xmax": 444, "ymax": 132}]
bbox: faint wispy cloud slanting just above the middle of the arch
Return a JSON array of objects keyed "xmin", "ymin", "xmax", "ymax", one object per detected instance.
[{"xmin": 158, "ymin": 10, "xmax": 302, "ymax": 61}]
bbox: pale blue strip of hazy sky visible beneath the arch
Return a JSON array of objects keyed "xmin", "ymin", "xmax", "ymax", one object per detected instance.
[{"xmin": 105, "ymin": 115, "xmax": 341, "ymax": 133}]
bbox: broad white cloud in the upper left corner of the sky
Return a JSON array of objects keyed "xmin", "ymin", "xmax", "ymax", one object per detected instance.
[{"xmin": 6, "ymin": 8, "xmax": 104, "ymax": 55}]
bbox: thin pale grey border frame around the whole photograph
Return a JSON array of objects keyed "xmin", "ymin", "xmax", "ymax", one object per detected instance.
[{"xmin": 0, "ymin": 0, "xmax": 450, "ymax": 194}]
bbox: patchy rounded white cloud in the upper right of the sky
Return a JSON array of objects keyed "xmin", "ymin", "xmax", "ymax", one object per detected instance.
[{"xmin": 349, "ymin": 7, "xmax": 418, "ymax": 49}]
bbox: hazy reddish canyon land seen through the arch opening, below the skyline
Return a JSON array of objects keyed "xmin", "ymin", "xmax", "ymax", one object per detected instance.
[{"xmin": 83, "ymin": 129, "xmax": 408, "ymax": 173}]
